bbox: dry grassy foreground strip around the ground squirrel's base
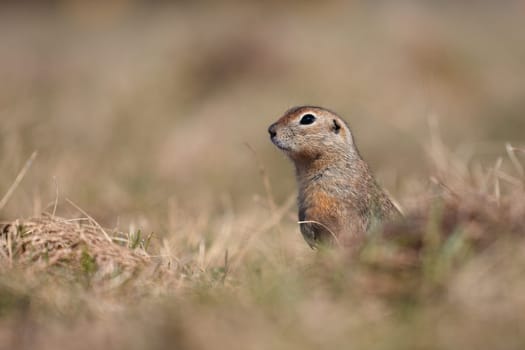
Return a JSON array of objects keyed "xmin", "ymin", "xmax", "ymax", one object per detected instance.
[{"xmin": 0, "ymin": 146, "xmax": 525, "ymax": 349}]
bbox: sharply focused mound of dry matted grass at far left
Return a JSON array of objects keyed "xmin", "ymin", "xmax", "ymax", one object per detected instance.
[{"xmin": 2, "ymin": 216, "xmax": 149, "ymax": 280}]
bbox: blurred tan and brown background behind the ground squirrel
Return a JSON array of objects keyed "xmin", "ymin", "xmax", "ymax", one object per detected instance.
[{"xmin": 0, "ymin": 0, "xmax": 525, "ymax": 229}]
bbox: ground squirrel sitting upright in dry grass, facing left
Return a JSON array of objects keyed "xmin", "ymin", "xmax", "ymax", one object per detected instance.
[{"xmin": 268, "ymin": 106, "xmax": 400, "ymax": 247}]
